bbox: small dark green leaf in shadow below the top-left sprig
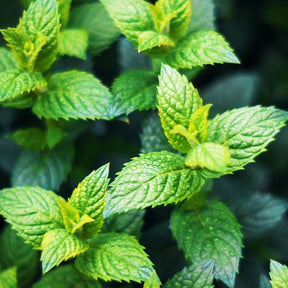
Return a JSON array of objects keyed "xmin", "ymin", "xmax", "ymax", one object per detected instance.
[{"xmin": 9, "ymin": 127, "xmax": 46, "ymax": 150}]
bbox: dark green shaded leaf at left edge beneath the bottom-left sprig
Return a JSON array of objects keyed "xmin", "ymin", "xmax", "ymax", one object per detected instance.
[{"xmin": 0, "ymin": 225, "xmax": 39, "ymax": 287}]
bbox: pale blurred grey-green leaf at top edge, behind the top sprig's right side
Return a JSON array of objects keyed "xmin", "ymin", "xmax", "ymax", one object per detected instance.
[{"xmin": 187, "ymin": 0, "xmax": 216, "ymax": 34}]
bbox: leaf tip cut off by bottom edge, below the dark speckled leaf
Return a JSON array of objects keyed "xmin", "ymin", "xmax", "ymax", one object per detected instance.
[{"xmin": 163, "ymin": 260, "xmax": 214, "ymax": 288}]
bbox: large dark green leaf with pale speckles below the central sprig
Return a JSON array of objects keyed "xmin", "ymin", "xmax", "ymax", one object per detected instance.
[{"xmin": 170, "ymin": 200, "xmax": 242, "ymax": 287}]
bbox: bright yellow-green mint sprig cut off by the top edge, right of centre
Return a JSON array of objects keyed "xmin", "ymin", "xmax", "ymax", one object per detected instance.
[{"xmin": 101, "ymin": 0, "xmax": 239, "ymax": 69}]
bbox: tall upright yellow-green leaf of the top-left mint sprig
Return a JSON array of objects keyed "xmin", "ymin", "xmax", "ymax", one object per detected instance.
[{"xmin": 18, "ymin": 0, "xmax": 60, "ymax": 72}]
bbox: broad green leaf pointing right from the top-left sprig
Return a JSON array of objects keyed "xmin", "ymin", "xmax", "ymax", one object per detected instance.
[{"xmin": 33, "ymin": 71, "xmax": 113, "ymax": 120}]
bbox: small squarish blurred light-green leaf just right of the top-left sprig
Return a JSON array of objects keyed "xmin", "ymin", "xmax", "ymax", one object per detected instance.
[{"xmin": 59, "ymin": 29, "xmax": 88, "ymax": 60}]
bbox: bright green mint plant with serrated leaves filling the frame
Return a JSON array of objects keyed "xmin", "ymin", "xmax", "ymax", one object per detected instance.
[{"xmin": 0, "ymin": 0, "xmax": 288, "ymax": 288}]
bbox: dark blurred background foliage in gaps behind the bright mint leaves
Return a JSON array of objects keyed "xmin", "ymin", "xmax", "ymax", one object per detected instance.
[{"xmin": 0, "ymin": 0, "xmax": 288, "ymax": 288}]
